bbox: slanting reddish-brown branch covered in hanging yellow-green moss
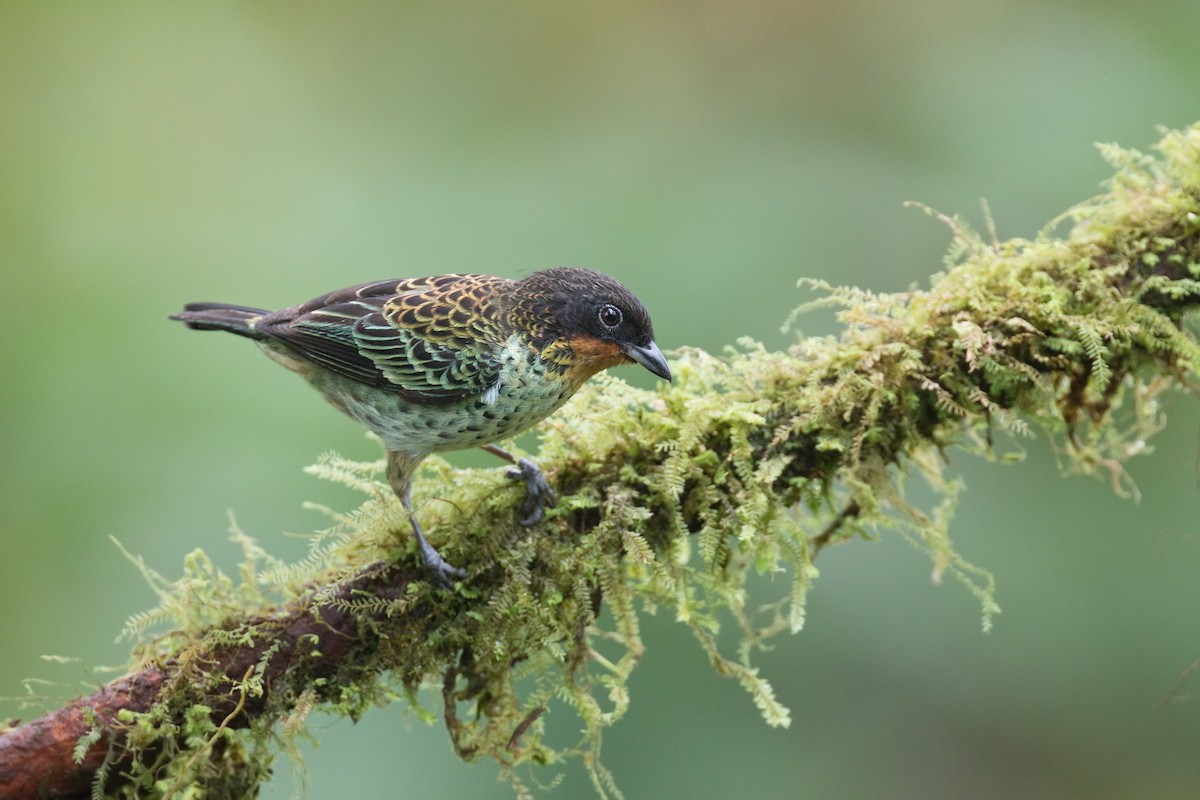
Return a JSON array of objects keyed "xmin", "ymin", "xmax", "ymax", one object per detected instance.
[{"xmin": 0, "ymin": 127, "xmax": 1200, "ymax": 798}]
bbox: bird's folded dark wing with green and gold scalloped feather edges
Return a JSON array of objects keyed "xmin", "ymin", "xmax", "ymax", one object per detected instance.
[{"xmin": 254, "ymin": 275, "xmax": 511, "ymax": 404}]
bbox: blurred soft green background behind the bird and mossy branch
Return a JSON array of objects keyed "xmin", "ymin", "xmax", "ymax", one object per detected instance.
[{"xmin": 0, "ymin": 0, "xmax": 1200, "ymax": 799}]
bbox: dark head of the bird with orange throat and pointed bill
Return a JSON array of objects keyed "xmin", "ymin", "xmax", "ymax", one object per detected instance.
[{"xmin": 510, "ymin": 266, "xmax": 671, "ymax": 380}]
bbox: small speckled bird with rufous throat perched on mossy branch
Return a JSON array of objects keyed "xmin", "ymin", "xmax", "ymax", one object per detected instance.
[{"xmin": 172, "ymin": 267, "xmax": 671, "ymax": 585}]
